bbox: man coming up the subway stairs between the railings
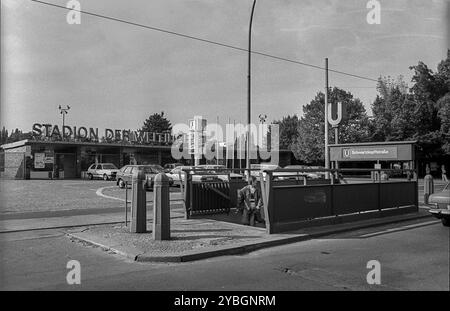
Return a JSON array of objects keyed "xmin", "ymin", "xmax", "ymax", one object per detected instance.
[{"xmin": 238, "ymin": 176, "xmax": 263, "ymax": 226}]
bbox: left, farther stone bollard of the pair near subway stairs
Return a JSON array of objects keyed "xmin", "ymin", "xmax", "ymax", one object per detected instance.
[{"xmin": 130, "ymin": 170, "xmax": 147, "ymax": 233}]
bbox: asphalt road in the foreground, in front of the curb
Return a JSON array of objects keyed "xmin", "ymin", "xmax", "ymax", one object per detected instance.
[{"xmin": 0, "ymin": 218, "xmax": 450, "ymax": 290}]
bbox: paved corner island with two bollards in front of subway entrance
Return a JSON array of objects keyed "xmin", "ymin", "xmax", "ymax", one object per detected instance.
[{"xmin": 66, "ymin": 210, "xmax": 431, "ymax": 262}]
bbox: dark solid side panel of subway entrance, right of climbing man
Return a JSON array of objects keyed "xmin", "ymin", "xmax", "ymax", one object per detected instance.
[{"xmin": 265, "ymin": 181, "xmax": 418, "ymax": 233}]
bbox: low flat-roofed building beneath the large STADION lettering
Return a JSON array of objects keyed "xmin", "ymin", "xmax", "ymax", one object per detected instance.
[{"xmin": 1, "ymin": 139, "xmax": 175, "ymax": 179}]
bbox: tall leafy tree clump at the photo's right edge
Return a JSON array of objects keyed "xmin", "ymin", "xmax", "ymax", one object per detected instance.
[{"xmin": 372, "ymin": 50, "xmax": 450, "ymax": 158}]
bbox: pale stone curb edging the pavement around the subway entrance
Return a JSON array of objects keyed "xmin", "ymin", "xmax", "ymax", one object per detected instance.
[{"xmin": 67, "ymin": 214, "xmax": 432, "ymax": 263}]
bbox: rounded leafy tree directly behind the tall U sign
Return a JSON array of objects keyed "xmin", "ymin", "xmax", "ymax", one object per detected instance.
[{"xmin": 292, "ymin": 87, "xmax": 369, "ymax": 164}]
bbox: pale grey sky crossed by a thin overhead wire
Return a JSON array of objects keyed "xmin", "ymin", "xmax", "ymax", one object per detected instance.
[{"xmin": 0, "ymin": 0, "xmax": 448, "ymax": 131}]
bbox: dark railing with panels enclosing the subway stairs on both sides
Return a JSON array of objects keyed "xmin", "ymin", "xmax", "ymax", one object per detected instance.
[{"xmin": 181, "ymin": 169, "xmax": 418, "ymax": 233}]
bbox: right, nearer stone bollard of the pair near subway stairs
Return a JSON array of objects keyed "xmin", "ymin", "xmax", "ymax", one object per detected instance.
[{"xmin": 153, "ymin": 173, "xmax": 170, "ymax": 241}]
